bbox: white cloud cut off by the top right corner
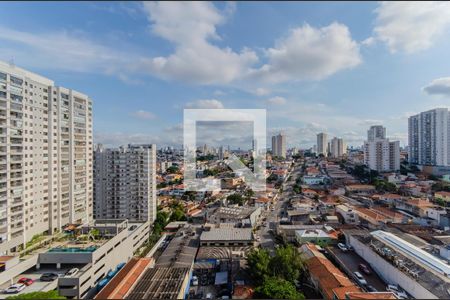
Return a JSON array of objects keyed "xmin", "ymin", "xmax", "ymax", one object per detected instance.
[{"xmin": 374, "ymin": 1, "xmax": 450, "ymax": 53}]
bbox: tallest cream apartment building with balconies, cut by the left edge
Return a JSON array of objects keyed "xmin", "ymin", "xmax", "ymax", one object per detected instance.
[{"xmin": 0, "ymin": 62, "xmax": 93, "ymax": 253}]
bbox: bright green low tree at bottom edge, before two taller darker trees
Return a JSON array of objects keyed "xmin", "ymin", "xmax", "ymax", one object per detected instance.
[{"xmin": 255, "ymin": 277, "xmax": 305, "ymax": 300}]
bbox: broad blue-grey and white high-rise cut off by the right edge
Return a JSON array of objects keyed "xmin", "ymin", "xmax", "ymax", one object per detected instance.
[{"xmin": 408, "ymin": 108, "xmax": 450, "ymax": 166}]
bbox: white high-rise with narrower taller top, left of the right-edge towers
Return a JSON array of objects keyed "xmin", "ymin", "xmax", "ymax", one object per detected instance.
[{"xmin": 364, "ymin": 126, "xmax": 400, "ymax": 172}]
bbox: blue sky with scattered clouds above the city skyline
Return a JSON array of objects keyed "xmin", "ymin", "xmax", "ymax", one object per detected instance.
[{"xmin": 0, "ymin": 2, "xmax": 450, "ymax": 148}]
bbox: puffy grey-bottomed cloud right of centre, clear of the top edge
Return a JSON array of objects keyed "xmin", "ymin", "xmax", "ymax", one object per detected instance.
[{"xmin": 252, "ymin": 23, "xmax": 361, "ymax": 82}]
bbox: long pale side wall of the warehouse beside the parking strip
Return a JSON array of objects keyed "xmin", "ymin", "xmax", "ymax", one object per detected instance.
[{"xmin": 348, "ymin": 236, "xmax": 438, "ymax": 299}]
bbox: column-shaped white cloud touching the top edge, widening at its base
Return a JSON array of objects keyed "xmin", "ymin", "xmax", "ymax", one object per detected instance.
[{"xmin": 144, "ymin": 2, "xmax": 258, "ymax": 84}]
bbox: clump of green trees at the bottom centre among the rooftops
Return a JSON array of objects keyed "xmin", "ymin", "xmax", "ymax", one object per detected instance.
[{"xmin": 247, "ymin": 245, "xmax": 304, "ymax": 299}]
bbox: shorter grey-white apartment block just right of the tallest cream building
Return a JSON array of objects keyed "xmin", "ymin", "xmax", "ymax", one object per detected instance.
[{"xmin": 94, "ymin": 144, "xmax": 157, "ymax": 223}]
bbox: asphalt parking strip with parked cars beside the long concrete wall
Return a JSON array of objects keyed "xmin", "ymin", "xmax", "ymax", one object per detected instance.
[{"xmin": 327, "ymin": 247, "xmax": 387, "ymax": 292}]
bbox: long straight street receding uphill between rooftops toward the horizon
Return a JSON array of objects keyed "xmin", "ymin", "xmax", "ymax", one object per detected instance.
[{"xmin": 256, "ymin": 164, "xmax": 301, "ymax": 254}]
